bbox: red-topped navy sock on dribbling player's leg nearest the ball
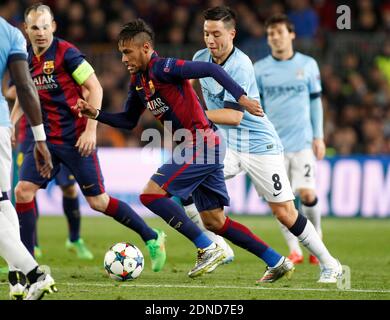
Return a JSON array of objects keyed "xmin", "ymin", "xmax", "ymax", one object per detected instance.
[{"xmin": 140, "ymin": 194, "xmax": 212, "ymax": 249}]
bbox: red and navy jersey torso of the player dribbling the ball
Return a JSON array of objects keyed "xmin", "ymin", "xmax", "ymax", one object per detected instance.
[{"xmin": 125, "ymin": 53, "xmax": 219, "ymax": 144}]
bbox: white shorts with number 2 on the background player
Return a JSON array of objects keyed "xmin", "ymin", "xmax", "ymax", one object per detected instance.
[{"xmin": 284, "ymin": 149, "xmax": 316, "ymax": 192}]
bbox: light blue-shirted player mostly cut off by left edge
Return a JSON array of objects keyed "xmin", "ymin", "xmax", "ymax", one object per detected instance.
[{"xmin": 0, "ymin": 17, "xmax": 57, "ymax": 300}]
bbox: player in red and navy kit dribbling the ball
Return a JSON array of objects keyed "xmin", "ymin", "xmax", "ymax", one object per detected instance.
[{"xmin": 76, "ymin": 19, "xmax": 293, "ymax": 278}]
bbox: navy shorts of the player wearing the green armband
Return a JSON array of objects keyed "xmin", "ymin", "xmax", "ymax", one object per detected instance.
[{"xmin": 19, "ymin": 143, "xmax": 105, "ymax": 197}]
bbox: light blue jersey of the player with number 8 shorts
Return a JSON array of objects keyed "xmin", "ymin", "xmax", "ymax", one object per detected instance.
[{"xmin": 193, "ymin": 48, "xmax": 283, "ymax": 154}]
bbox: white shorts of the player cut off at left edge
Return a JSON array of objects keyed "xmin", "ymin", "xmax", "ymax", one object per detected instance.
[{"xmin": 0, "ymin": 127, "xmax": 12, "ymax": 192}]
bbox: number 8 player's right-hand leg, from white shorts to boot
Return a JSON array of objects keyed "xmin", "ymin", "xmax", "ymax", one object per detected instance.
[{"xmin": 251, "ymin": 155, "xmax": 342, "ymax": 282}]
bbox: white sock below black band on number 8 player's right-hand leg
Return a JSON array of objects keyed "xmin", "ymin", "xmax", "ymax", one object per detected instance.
[{"xmin": 298, "ymin": 220, "xmax": 337, "ymax": 268}]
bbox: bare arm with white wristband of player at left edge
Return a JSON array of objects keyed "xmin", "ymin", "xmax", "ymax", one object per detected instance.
[{"xmin": 8, "ymin": 59, "xmax": 53, "ymax": 178}]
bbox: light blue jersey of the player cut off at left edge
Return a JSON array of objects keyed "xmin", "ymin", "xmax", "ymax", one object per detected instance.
[{"xmin": 0, "ymin": 17, "xmax": 27, "ymax": 127}]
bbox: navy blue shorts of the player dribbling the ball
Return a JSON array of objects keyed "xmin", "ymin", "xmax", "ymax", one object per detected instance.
[{"xmin": 151, "ymin": 146, "xmax": 230, "ymax": 212}]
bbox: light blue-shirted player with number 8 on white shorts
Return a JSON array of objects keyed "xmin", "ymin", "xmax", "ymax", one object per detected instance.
[{"xmin": 181, "ymin": 7, "xmax": 342, "ymax": 283}]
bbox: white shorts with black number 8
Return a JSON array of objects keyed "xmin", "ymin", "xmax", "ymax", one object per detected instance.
[{"xmin": 223, "ymin": 148, "xmax": 295, "ymax": 202}]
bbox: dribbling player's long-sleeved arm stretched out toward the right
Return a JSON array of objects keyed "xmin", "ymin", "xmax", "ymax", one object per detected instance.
[{"xmin": 155, "ymin": 59, "xmax": 264, "ymax": 116}]
